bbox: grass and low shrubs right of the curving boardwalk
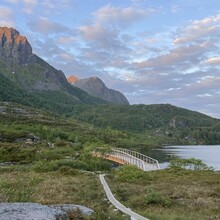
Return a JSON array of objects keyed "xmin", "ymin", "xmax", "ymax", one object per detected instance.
[{"xmin": 108, "ymin": 166, "xmax": 220, "ymax": 220}]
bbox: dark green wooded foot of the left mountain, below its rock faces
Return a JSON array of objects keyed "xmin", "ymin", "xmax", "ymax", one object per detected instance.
[{"xmin": 0, "ymin": 72, "xmax": 105, "ymax": 113}]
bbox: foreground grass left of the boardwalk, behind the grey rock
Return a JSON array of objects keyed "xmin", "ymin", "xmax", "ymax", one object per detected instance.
[{"xmin": 0, "ymin": 166, "xmax": 128, "ymax": 220}]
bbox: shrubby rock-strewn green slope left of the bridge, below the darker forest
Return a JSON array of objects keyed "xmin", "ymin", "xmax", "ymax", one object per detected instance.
[{"xmin": 0, "ymin": 102, "xmax": 149, "ymax": 163}]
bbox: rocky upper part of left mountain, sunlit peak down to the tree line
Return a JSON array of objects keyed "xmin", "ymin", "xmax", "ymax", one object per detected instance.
[{"xmin": 0, "ymin": 27, "xmax": 67, "ymax": 91}]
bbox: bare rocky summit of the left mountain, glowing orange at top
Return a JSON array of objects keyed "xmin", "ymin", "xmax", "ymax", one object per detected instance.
[{"xmin": 0, "ymin": 27, "xmax": 32, "ymax": 64}]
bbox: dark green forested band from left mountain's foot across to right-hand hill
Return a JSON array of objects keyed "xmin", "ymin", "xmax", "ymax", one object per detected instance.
[{"xmin": 0, "ymin": 69, "xmax": 220, "ymax": 145}]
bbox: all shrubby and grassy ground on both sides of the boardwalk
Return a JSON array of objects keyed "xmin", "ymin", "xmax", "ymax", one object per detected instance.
[{"xmin": 0, "ymin": 102, "xmax": 220, "ymax": 220}]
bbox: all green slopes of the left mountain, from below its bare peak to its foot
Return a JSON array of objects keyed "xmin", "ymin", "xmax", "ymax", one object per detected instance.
[{"xmin": 0, "ymin": 62, "xmax": 106, "ymax": 114}]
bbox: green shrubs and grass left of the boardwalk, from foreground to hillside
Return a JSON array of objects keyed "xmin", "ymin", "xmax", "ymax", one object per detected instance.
[{"xmin": 0, "ymin": 103, "xmax": 131, "ymax": 220}]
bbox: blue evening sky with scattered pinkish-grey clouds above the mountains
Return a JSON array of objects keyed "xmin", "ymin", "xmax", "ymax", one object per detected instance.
[{"xmin": 0, "ymin": 0, "xmax": 220, "ymax": 118}]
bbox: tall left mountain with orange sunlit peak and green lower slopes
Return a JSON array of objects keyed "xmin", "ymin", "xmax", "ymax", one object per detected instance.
[{"xmin": 0, "ymin": 27, "xmax": 106, "ymax": 109}]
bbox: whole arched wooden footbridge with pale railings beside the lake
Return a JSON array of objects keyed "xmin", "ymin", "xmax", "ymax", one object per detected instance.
[{"xmin": 93, "ymin": 148, "xmax": 160, "ymax": 171}]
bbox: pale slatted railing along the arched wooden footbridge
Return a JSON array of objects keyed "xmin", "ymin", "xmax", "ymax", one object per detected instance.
[{"xmin": 112, "ymin": 148, "xmax": 160, "ymax": 169}]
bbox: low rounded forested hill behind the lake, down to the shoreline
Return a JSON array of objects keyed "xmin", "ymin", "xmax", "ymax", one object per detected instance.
[{"xmin": 70, "ymin": 104, "xmax": 220, "ymax": 144}]
